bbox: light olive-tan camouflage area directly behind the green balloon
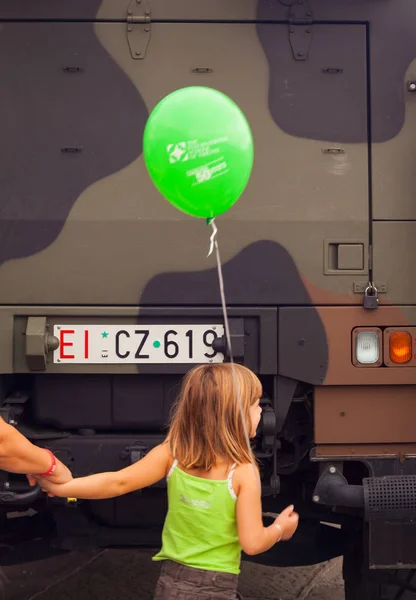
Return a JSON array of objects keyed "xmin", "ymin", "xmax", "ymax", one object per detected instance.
[{"xmin": 0, "ymin": 14, "xmax": 368, "ymax": 305}]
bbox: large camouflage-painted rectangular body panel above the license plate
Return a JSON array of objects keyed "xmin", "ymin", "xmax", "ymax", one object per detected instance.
[{"xmin": 0, "ymin": 17, "xmax": 369, "ymax": 305}]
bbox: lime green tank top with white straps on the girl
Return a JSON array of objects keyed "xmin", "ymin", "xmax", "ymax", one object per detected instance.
[{"xmin": 153, "ymin": 460, "xmax": 241, "ymax": 575}]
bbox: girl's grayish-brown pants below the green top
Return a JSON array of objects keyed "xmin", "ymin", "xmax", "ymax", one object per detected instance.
[{"xmin": 154, "ymin": 560, "xmax": 242, "ymax": 600}]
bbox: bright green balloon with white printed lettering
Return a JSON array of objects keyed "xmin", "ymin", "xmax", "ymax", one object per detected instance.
[{"xmin": 143, "ymin": 87, "xmax": 254, "ymax": 218}]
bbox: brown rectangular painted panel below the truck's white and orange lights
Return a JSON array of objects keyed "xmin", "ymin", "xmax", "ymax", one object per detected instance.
[{"xmin": 314, "ymin": 386, "xmax": 416, "ymax": 444}]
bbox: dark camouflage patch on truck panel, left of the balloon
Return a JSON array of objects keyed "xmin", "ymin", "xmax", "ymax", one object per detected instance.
[{"xmin": 0, "ymin": 16, "xmax": 148, "ymax": 263}]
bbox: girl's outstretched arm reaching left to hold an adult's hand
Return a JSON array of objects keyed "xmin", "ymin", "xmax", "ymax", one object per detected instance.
[{"xmin": 38, "ymin": 443, "xmax": 170, "ymax": 500}]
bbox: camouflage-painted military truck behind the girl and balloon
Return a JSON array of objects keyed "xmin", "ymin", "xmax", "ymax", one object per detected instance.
[{"xmin": 0, "ymin": 0, "xmax": 416, "ymax": 600}]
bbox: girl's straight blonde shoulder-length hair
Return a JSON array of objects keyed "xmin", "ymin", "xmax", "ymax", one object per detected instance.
[{"xmin": 167, "ymin": 363, "xmax": 262, "ymax": 471}]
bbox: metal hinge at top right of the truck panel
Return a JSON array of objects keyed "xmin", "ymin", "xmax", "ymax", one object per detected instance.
[{"xmin": 280, "ymin": 0, "xmax": 313, "ymax": 60}]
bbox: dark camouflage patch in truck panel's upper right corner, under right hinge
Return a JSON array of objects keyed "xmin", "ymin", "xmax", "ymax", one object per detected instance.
[{"xmin": 257, "ymin": 22, "xmax": 367, "ymax": 144}]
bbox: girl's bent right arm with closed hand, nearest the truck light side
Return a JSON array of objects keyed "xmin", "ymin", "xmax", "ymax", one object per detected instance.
[{"xmin": 233, "ymin": 464, "xmax": 299, "ymax": 555}]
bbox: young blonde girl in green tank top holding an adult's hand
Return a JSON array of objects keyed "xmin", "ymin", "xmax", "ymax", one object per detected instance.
[{"xmin": 35, "ymin": 364, "xmax": 299, "ymax": 600}]
